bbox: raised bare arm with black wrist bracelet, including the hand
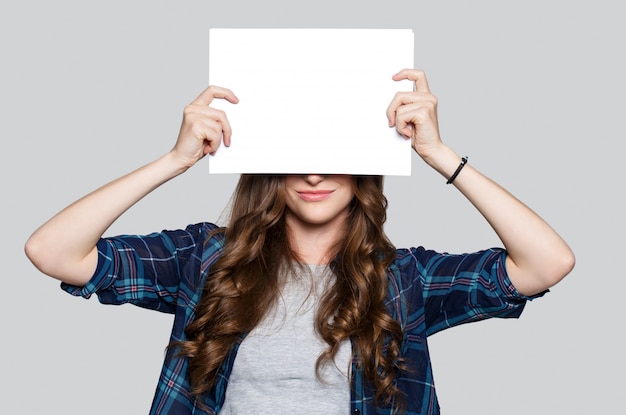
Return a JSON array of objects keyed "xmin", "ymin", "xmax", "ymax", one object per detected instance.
[{"xmin": 387, "ymin": 69, "xmax": 575, "ymax": 295}]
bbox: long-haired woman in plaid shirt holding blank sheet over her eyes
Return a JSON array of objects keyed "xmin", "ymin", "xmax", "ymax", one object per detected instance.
[{"xmin": 25, "ymin": 69, "xmax": 574, "ymax": 415}]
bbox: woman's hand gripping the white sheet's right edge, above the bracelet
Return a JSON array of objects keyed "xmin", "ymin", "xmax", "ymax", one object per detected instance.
[{"xmin": 387, "ymin": 69, "xmax": 442, "ymax": 158}]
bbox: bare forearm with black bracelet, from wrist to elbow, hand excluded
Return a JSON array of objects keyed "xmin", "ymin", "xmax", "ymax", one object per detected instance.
[{"xmin": 424, "ymin": 145, "xmax": 574, "ymax": 295}]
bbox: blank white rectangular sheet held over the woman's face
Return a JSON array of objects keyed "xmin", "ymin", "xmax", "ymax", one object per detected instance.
[{"xmin": 209, "ymin": 29, "xmax": 413, "ymax": 176}]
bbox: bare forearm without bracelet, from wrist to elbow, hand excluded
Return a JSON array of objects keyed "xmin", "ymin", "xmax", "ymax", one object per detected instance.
[{"xmin": 25, "ymin": 153, "xmax": 186, "ymax": 285}]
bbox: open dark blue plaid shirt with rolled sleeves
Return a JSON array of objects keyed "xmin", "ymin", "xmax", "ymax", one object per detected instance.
[{"xmin": 62, "ymin": 223, "xmax": 540, "ymax": 415}]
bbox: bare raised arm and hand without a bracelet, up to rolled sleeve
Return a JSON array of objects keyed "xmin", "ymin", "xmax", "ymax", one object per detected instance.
[{"xmin": 24, "ymin": 86, "xmax": 238, "ymax": 286}]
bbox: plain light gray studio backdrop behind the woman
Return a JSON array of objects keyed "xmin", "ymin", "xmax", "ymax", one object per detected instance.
[{"xmin": 0, "ymin": 0, "xmax": 626, "ymax": 415}]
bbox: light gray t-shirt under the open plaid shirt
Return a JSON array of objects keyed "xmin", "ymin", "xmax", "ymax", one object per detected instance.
[{"xmin": 220, "ymin": 265, "xmax": 352, "ymax": 415}]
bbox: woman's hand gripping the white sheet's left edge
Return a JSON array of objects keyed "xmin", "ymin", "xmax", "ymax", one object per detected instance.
[{"xmin": 171, "ymin": 85, "xmax": 239, "ymax": 168}]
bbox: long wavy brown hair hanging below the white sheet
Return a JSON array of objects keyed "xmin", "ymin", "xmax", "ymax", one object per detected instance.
[{"xmin": 173, "ymin": 175, "xmax": 405, "ymax": 409}]
